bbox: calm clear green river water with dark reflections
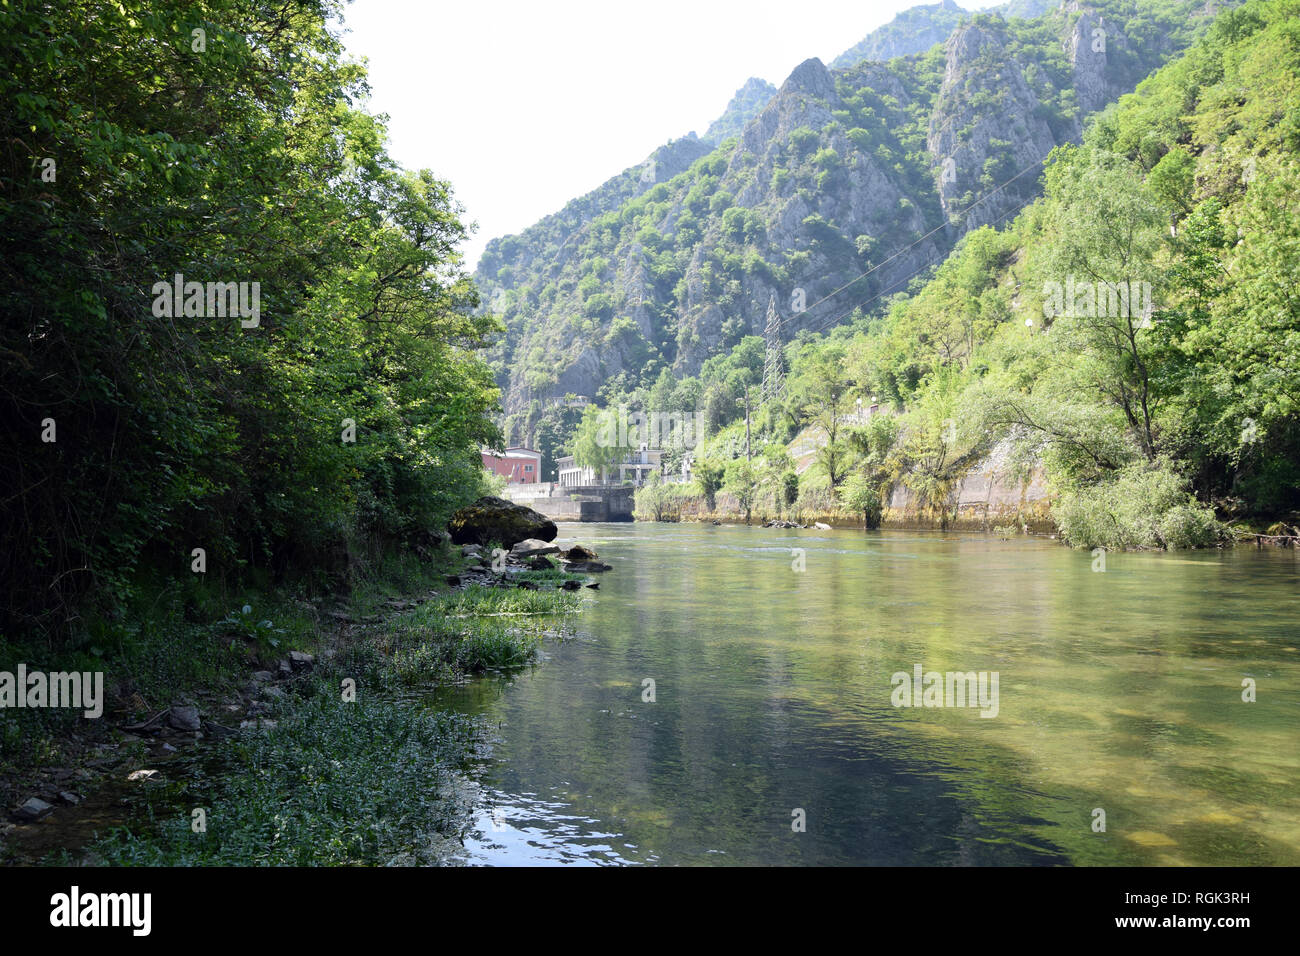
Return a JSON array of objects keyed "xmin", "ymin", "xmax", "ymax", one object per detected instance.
[{"xmin": 438, "ymin": 523, "xmax": 1300, "ymax": 865}]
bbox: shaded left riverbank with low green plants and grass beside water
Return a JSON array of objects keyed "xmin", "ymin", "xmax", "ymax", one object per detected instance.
[{"xmin": 0, "ymin": 546, "xmax": 581, "ymax": 865}]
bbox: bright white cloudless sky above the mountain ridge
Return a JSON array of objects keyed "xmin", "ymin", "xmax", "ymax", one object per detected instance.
[{"xmin": 343, "ymin": 0, "xmax": 995, "ymax": 269}]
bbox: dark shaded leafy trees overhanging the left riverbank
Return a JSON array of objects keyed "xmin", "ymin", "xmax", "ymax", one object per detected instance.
[{"xmin": 0, "ymin": 0, "xmax": 498, "ymax": 636}]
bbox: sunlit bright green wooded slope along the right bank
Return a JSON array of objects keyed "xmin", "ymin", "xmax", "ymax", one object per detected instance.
[{"xmin": 647, "ymin": 0, "xmax": 1300, "ymax": 548}]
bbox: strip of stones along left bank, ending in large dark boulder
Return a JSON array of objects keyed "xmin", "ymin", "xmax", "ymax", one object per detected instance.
[{"xmin": 0, "ymin": 498, "xmax": 598, "ymax": 864}]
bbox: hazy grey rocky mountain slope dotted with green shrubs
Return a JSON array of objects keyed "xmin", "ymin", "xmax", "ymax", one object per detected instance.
[{"xmin": 476, "ymin": 0, "xmax": 1227, "ymax": 438}]
